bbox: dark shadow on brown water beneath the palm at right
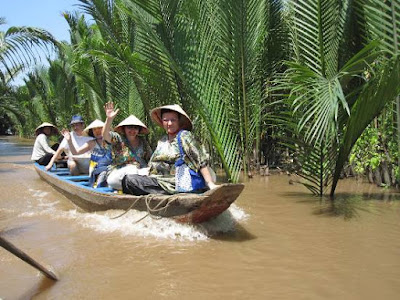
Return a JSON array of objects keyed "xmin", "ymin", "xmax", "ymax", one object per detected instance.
[{"xmin": 286, "ymin": 191, "xmax": 400, "ymax": 220}]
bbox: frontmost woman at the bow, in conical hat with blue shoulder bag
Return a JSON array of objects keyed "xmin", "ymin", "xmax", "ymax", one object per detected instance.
[{"xmin": 122, "ymin": 104, "xmax": 216, "ymax": 196}]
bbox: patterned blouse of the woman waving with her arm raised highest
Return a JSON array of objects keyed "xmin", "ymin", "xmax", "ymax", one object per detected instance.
[{"xmin": 109, "ymin": 131, "xmax": 152, "ymax": 172}]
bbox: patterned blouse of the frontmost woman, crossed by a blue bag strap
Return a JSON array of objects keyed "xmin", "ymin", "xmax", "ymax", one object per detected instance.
[{"xmin": 149, "ymin": 130, "xmax": 208, "ymax": 194}]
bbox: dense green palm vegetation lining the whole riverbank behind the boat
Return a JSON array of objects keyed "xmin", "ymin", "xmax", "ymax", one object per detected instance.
[{"xmin": 0, "ymin": 0, "xmax": 400, "ymax": 196}]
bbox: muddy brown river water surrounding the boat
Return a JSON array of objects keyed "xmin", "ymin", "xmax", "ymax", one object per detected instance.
[{"xmin": 0, "ymin": 137, "xmax": 400, "ymax": 300}]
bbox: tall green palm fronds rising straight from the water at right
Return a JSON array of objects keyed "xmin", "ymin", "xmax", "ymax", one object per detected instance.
[{"xmin": 277, "ymin": 0, "xmax": 378, "ymax": 196}]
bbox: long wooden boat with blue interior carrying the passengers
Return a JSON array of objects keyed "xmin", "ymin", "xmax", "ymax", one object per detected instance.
[{"xmin": 34, "ymin": 163, "xmax": 244, "ymax": 223}]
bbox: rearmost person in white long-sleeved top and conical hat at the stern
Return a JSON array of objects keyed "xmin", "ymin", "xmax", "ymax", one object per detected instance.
[{"xmin": 31, "ymin": 122, "xmax": 58, "ymax": 166}]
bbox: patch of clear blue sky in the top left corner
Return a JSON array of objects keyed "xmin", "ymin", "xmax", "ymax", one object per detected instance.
[{"xmin": 0, "ymin": 0, "xmax": 83, "ymax": 42}]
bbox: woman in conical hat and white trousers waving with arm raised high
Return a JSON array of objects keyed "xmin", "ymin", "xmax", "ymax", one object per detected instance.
[{"xmin": 103, "ymin": 102, "xmax": 152, "ymax": 190}]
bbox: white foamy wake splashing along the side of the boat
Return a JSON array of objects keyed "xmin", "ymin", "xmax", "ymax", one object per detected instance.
[{"xmin": 19, "ymin": 203, "xmax": 248, "ymax": 241}]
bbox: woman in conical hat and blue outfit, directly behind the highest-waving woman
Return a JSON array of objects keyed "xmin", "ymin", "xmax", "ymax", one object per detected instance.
[{"xmin": 61, "ymin": 120, "xmax": 112, "ymax": 187}]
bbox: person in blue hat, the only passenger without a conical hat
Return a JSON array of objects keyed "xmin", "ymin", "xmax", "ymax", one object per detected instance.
[{"xmin": 46, "ymin": 115, "xmax": 93, "ymax": 175}]
